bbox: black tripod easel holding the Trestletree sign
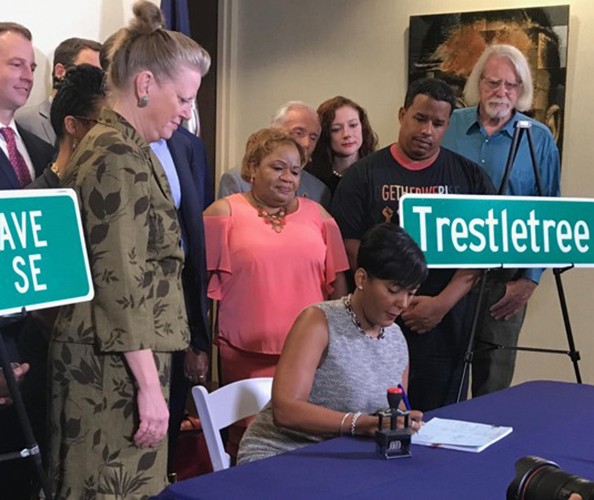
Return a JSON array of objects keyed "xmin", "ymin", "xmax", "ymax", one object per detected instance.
[{"xmin": 456, "ymin": 120, "xmax": 582, "ymax": 401}]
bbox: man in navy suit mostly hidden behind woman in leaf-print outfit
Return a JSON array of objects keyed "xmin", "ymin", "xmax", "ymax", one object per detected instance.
[{"xmin": 153, "ymin": 128, "xmax": 213, "ymax": 472}]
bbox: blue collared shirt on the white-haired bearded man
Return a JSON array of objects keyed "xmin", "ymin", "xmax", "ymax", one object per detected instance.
[{"xmin": 441, "ymin": 106, "xmax": 560, "ymax": 283}]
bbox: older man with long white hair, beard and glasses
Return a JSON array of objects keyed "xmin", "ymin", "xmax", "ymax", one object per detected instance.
[{"xmin": 442, "ymin": 45, "xmax": 560, "ymax": 396}]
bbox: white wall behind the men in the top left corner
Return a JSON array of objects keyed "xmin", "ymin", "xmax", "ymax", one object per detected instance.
[{"xmin": 0, "ymin": 0, "xmax": 159, "ymax": 104}]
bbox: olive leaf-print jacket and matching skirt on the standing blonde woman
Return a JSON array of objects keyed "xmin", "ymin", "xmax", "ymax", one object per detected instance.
[{"xmin": 50, "ymin": 109, "xmax": 189, "ymax": 499}]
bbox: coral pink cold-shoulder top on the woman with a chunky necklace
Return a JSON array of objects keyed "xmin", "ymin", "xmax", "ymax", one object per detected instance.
[{"xmin": 204, "ymin": 194, "xmax": 348, "ymax": 354}]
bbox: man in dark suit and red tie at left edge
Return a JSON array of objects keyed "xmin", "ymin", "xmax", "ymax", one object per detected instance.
[{"xmin": 0, "ymin": 22, "xmax": 53, "ymax": 499}]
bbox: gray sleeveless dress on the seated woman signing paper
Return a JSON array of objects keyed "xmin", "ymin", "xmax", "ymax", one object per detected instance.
[{"xmin": 237, "ymin": 299, "xmax": 408, "ymax": 464}]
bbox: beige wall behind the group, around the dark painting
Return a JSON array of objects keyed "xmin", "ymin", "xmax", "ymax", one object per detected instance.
[{"xmin": 218, "ymin": 0, "xmax": 594, "ymax": 383}]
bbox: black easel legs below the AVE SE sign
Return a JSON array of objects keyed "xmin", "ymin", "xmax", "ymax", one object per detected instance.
[{"xmin": 0, "ymin": 308, "xmax": 52, "ymax": 500}]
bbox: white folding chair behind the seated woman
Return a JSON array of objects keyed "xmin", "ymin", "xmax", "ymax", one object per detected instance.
[{"xmin": 192, "ymin": 377, "xmax": 272, "ymax": 472}]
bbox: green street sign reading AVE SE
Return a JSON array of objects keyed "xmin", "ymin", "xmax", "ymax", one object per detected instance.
[{"xmin": 0, "ymin": 189, "xmax": 94, "ymax": 315}]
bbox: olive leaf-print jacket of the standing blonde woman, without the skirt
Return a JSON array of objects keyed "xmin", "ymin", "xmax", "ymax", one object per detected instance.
[{"xmin": 53, "ymin": 108, "xmax": 189, "ymax": 352}]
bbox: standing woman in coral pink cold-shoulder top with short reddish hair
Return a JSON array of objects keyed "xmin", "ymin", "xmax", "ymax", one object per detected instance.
[{"xmin": 204, "ymin": 129, "xmax": 348, "ymax": 454}]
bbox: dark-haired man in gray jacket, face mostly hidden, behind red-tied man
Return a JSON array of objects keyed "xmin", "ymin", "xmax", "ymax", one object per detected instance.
[{"xmin": 16, "ymin": 38, "xmax": 101, "ymax": 146}]
